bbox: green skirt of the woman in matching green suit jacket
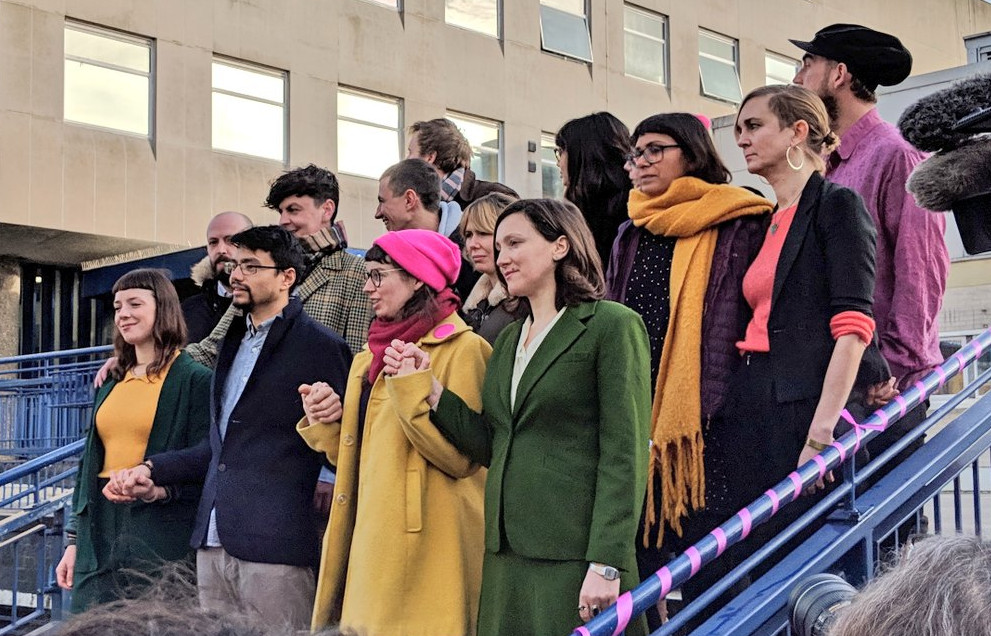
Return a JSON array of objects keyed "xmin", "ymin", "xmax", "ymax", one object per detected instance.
[{"xmin": 478, "ymin": 545, "xmax": 647, "ymax": 636}]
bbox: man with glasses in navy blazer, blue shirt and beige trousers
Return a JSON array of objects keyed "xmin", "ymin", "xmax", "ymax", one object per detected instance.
[{"xmin": 108, "ymin": 226, "xmax": 351, "ymax": 629}]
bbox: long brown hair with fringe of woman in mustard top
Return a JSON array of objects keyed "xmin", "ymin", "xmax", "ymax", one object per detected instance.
[{"xmin": 111, "ymin": 269, "xmax": 186, "ymax": 380}]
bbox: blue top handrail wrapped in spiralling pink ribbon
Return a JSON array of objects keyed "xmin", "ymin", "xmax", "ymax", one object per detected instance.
[{"xmin": 572, "ymin": 329, "xmax": 991, "ymax": 636}]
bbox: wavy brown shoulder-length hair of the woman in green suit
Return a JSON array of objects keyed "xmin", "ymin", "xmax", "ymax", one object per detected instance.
[{"xmin": 495, "ymin": 199, "xmax": 606, "ymax": 309}]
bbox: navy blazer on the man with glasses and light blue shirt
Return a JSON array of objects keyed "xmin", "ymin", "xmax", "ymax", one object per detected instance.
[{"xmin": 150, "ymin": 297, "xmax": 351, "ymax": 566}]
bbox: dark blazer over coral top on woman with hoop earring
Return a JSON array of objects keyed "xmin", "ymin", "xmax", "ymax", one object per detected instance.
[{"xmin": 767, "ymin": 173, "xmax": 888, "ymax": 402}]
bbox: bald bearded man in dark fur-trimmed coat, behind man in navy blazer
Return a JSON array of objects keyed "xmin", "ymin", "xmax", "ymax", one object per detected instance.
[{"xmin": 182, "ymin": 212, "xmax": 253, "ymax": 342}]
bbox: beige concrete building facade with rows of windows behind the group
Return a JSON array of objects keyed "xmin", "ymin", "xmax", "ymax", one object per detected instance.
[{"xmin": 0, "ymin": 0, "xmax": 991, "ymax": 354}]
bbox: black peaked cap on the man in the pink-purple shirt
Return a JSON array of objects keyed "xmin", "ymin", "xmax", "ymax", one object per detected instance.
[{"xmin": 790, "ymin": 24, "xmax": 912, "ymax": 90}]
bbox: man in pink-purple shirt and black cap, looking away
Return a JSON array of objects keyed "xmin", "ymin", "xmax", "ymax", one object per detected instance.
[{"xmin": 791, "ymin": 24, "xmax": 949, "ymax": 465}]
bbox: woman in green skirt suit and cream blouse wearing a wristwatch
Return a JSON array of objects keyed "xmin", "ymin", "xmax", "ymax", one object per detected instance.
[{"xmin": 386, "ymin": 199, "xmax": 650, "ymax": 636}]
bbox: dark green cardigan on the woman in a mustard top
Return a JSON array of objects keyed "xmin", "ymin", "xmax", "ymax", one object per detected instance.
[{"xmin": 67, "ymin": 352, "xmax": 213, "ymax": 573}]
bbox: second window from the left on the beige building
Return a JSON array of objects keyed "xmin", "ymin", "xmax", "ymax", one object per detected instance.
[{"xmin": 213, "ymin": 58, "xmax": 287, "ymax": 162}]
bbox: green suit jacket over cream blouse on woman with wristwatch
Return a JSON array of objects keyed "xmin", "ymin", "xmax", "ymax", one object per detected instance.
[{"xmin": 433, "ymin": 301, "xmax": 651, "ymax": 569}]
